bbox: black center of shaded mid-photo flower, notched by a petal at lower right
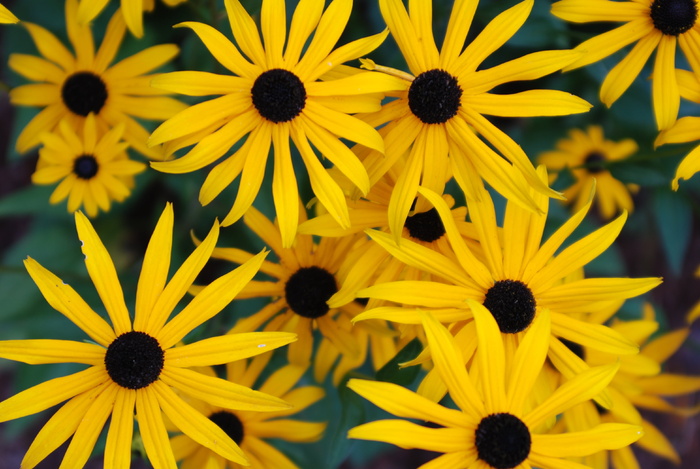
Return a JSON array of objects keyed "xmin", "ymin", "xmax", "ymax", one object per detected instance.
[{"xmin": 284, "ymin": 266, "xmax": 338, "ymax": 319}]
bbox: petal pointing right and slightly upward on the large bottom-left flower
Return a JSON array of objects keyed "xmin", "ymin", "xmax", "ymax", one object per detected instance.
[{"xmin": 165, "ymin": 330, "xmax": 296, "ymax": 368}]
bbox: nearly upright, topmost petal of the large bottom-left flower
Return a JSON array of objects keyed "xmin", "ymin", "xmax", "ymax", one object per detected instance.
[{"xmin": 134, "ymin": 203, "xmax": 174, "ymax": 330}]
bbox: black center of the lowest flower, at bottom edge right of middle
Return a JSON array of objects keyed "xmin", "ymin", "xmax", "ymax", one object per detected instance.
[{"xmin": 475, "ymin": 413, "xmax": 532, "ymax": 469}]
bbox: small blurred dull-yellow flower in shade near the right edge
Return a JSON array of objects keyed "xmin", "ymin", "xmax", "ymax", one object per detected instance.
[{"xmin": 537, "ymin": 125, "xmax": 638, "ymax": 220}]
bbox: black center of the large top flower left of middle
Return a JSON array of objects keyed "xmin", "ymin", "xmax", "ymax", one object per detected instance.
[{"xmin": 251, "ymin": 68, "xmax": 306, "ymax": 124}]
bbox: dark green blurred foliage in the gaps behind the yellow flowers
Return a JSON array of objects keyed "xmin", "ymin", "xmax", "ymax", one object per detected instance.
[{"xmin": 0, "ymin": 0, "xmax": 700, "ymax": 468}]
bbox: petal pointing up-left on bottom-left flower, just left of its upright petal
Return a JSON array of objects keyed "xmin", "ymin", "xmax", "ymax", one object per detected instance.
[{"xmin": 75, "ymin": 212, "xmax": 131, "ymax": 335}]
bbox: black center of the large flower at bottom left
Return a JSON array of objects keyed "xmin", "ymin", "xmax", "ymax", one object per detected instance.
[{"xmin": 105, "ymin": 331, "xmax": 165, "ymax": 389}]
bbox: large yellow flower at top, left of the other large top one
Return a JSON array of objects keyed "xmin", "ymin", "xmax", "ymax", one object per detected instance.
[{"xmin": 150, "ymin": 0, "xmax": 403, "ymax": 247}]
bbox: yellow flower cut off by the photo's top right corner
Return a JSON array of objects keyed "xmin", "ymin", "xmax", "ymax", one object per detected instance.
[{"xmin": 552, "ymin": 0, "xmax": 700, "ymax": 130}]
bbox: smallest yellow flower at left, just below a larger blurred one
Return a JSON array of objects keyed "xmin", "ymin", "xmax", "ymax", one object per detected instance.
[{"xmin": 32, "ymin": 113, "xmax": 146, "ymax": 217}]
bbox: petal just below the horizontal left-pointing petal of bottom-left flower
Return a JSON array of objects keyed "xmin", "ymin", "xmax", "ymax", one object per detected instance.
[{"xmin": 0, "ymin": 365, "xmax": 109, "ymax": 422}]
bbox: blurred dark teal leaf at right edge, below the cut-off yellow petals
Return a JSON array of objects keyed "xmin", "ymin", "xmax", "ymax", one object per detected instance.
[{"xmin": 652, "ymin": 189, "xmax": 693, "ymax": 275}]
